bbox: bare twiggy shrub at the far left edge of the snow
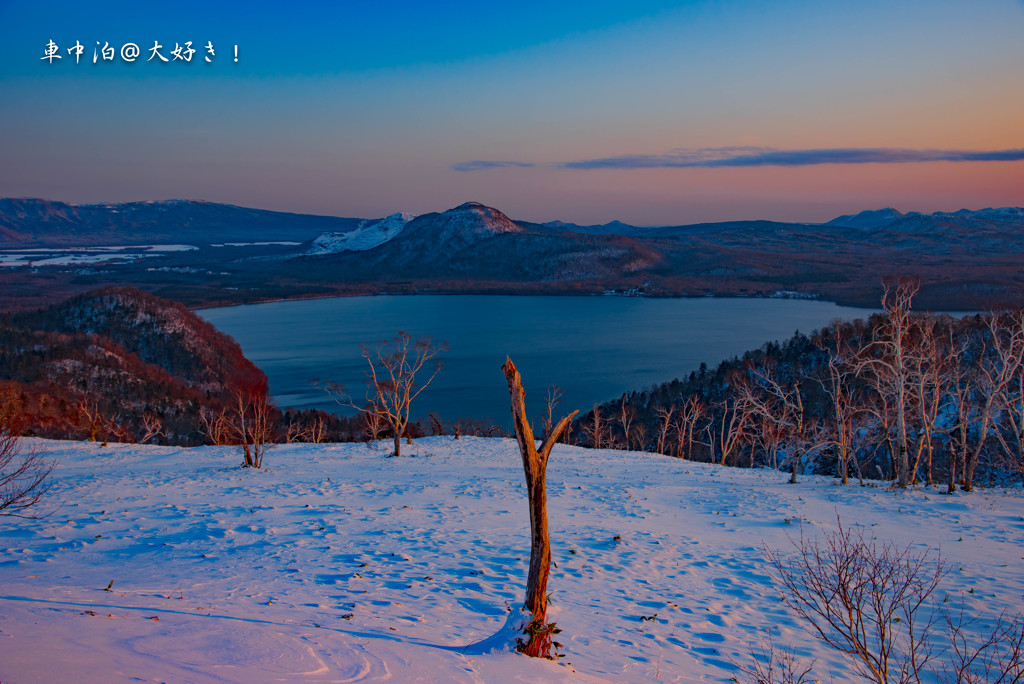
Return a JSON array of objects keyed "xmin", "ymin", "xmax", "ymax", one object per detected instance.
[{"xmin": 0, "ymin": 394, "xmax": 55, "ymax": 518}]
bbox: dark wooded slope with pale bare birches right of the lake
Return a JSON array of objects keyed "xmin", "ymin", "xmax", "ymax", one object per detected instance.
[{"xmin": 575, "ymin": 280, "xmax": 1024, "ymax": 491}]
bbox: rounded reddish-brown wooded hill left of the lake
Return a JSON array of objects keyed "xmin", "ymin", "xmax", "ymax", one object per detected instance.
[{"xmin": 0, "ymin": 288, "xmax": 266, "ymax": 443}]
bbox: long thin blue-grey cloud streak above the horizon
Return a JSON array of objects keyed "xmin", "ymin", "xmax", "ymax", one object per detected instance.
[{"xmin": 452, "ymin": 147, "xmax": 1024, "ymax": 171}]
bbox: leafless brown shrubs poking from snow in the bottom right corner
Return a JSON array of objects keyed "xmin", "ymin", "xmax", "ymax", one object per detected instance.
[{"xmin": 765, "ymin": 522, "xmax": 1024, "ymax": 684}]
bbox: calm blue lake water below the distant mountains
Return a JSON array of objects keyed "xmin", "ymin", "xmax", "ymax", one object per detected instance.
[{"xmin": 199, "ymin": 295, "xmax": 870, "ymax": 424}]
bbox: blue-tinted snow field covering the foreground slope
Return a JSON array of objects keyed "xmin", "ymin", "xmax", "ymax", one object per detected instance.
[{"xmin": 0, "ymin": 437, "xmax": 1024, "ymax": 682}]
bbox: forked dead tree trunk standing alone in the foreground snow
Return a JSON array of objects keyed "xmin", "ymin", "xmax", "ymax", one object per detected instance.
[{"xmin": 502, "ymin": 357, "xmax": 579, "ymax": 658}]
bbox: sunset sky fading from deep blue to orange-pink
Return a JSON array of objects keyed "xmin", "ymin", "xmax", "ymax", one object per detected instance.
[{"xmin": 0, "ymin": 0, "xmax": 1024, "ymax": 224}]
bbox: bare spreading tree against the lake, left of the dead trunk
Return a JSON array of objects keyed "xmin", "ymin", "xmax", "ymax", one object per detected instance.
[{"xmin": 328, "ymin": 331, "xmax": 447, "ymax": 457}]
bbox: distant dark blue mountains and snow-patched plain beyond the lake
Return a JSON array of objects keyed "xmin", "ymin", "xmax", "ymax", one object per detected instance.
[{"xmin": 0, "ymin": 194, "xmax": 1024, "ymax": 308}]
